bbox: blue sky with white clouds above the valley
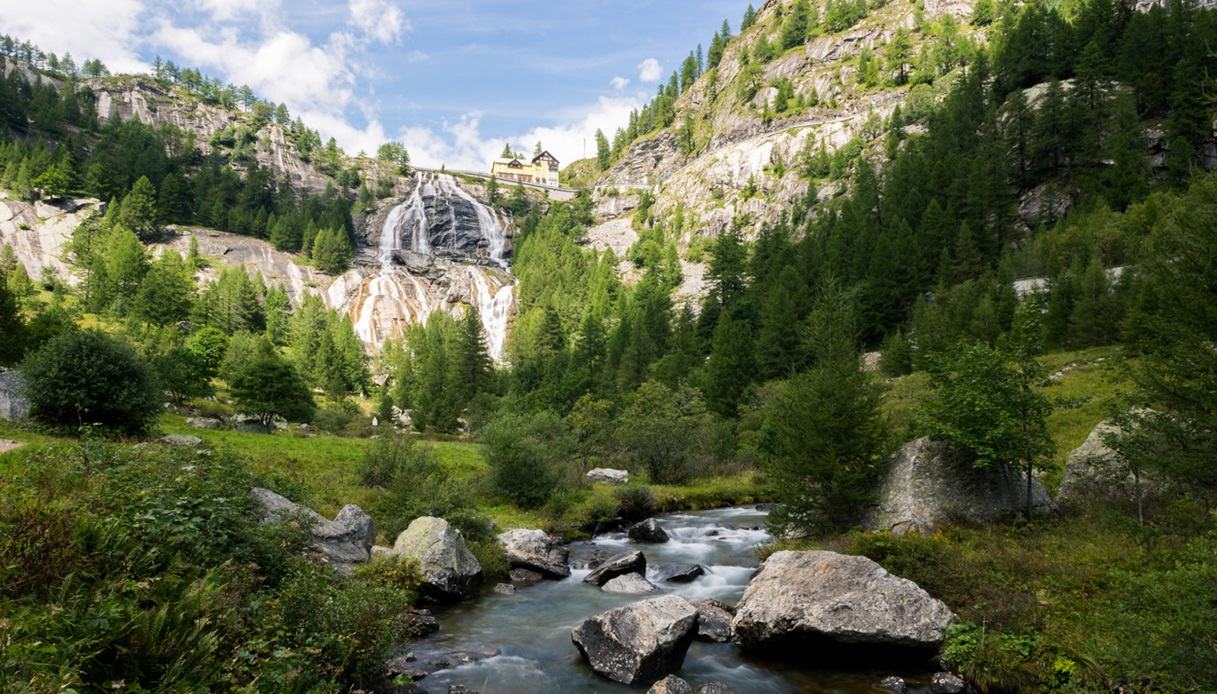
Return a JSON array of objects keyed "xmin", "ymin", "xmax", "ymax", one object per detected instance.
[{"xmin": 0, "ymin": 0, "xmax": 747, "ymax": 170}]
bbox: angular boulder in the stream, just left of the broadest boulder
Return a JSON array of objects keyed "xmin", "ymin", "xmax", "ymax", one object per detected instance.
[{"xmin": 571, "ymin": 595, "xmax": 697, "ymax": 684}]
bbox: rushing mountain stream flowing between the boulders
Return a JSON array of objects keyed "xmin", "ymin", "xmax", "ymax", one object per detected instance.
[{"xmin": 414, "ymin": 508, "xmax": 927, "ymax": 694}]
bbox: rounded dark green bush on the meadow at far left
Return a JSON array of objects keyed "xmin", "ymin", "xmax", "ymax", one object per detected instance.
[{"xmin": 19, "ymin": 330, "xmax": 162, "ymax": 433}]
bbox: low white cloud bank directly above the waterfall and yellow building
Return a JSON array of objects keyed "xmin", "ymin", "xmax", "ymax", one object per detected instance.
[{"xmin": 400, "ymin": 95, "xmax": 644, "ymax": 170}]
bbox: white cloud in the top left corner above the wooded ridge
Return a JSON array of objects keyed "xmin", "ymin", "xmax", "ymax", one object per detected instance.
[{"xmin": 0, "ymin": 0, "xmax": 148, "ymax": 72}]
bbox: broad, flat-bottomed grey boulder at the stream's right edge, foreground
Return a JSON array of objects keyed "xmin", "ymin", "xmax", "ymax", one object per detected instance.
[{"xmin": 731, "ymin": 552, "xmax": 955, "ymax": 653}]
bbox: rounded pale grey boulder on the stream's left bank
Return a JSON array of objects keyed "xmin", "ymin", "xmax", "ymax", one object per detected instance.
[{"xmin": 393, "ymin": 516, "xmax": 482, "ymax": 600}]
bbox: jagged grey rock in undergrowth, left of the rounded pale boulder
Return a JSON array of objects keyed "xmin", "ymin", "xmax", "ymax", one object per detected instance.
[{"xmin": 251, "ymin": 487, "xmax": 376, "ymax": 575}]
